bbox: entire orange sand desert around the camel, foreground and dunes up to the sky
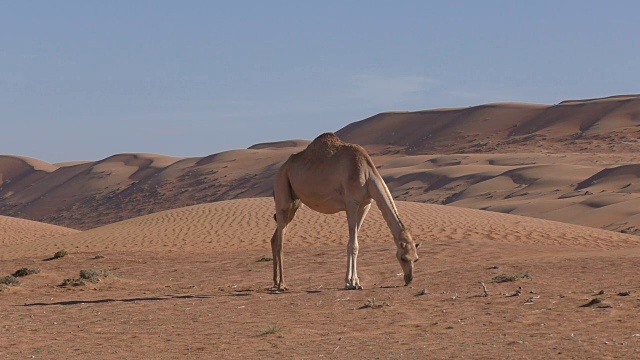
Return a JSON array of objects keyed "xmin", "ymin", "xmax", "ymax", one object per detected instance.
[{"xmin": 0, "ymin": 95, "xmax": 640, "ymax": 359}]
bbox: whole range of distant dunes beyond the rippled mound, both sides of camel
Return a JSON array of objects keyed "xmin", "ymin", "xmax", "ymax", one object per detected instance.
[{"xmin": 0, "ymin": 95, "xmax": 640, "ymax": 234}]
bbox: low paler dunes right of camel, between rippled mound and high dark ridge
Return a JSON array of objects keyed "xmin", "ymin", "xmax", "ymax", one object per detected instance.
[{"xmin": 372, "ymin": 153, "xmax": 640, "ymax": 233}]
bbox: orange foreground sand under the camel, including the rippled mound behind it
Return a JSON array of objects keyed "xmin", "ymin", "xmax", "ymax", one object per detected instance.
[{"xmin": 0, "ymin": 198, "xmax": 640, "ymax": 359}]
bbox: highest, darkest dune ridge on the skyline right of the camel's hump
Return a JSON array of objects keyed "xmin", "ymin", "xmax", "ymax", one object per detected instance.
[{"xmin": 337, "ymin": 95, "xmax": 640, "ymax": 154}]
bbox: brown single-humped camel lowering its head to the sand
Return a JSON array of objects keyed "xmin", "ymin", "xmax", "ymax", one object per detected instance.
[{"xmin": 271, "ymin": 133, "xmax": 419, "ymax": 291}]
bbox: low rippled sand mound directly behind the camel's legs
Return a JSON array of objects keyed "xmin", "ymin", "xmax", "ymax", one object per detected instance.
[{"xmin": 6, "ymin": 198, "xmax": 640, "ymax": 259}]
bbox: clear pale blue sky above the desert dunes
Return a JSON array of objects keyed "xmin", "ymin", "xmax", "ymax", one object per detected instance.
[{"xmin": 0, "ymin": 0, "xmax": 640, "ymax": 162}]
